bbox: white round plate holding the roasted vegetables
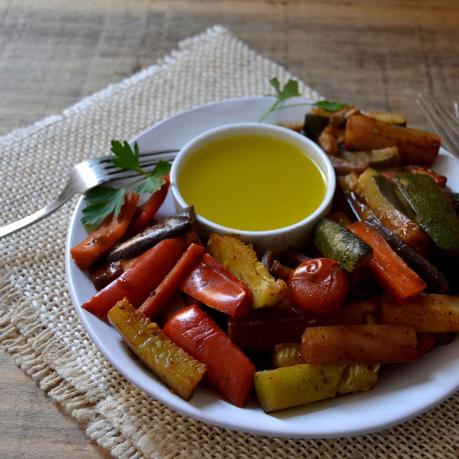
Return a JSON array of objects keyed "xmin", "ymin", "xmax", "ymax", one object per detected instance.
[{"xmin": 66, "ymin": 97, "xmax": 459, "ymax": 438}]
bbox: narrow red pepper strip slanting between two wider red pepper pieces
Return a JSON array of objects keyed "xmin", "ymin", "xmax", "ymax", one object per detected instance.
[{"xmin": 139, "ymin": 244, "xmax": 206, "ymax": 318}]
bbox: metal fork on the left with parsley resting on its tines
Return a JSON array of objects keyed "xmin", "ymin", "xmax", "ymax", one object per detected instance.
[{"xmin": 0, "ymin": 150, "xmax": 179, "ymax": 239}]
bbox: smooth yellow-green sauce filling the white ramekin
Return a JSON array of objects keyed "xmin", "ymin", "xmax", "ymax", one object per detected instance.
[{"xmin": 177, "ymin": 134, "xmax": 325, "ymax": 231}]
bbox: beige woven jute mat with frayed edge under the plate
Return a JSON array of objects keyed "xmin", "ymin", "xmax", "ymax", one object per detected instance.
[{"xmin": 0, "ymin": 26, "xmax": 459, "ymax": 459}]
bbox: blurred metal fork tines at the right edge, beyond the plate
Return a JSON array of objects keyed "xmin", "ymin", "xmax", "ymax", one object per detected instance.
[{"xmin": 417, "ymin": 91, "xmax": 459, "ymax": 159}]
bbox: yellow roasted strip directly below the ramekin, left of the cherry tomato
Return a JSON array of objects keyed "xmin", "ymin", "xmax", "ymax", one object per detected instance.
[{"xmin": 207, "ymin": 234, "xmax": 287, "ymax": 308}]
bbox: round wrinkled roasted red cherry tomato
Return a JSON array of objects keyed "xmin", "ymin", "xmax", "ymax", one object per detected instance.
[{"xmin": 288, "ymin": 258, "xmax": 349, "ymax": 314}]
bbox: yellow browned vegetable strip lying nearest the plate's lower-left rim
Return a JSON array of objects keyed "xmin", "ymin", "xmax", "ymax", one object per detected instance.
[{"xmin": 108, "ymin": 298, "xmax": 206, "ymax": 400}]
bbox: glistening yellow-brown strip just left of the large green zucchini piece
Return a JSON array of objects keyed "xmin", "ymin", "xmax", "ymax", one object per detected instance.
[{"xmin": 355, "ymin": 169, "xmax": 429, "ymax": 253}]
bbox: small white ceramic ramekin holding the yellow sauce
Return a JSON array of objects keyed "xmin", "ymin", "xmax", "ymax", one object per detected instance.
[{"xmin": 170, "ymin": 123, "xmax": 336, "ymax": 252}]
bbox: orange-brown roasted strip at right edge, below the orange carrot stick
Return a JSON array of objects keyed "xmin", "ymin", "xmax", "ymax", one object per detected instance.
[{"xmin": 380, "ymin": 293, "xmax": 459, "ymax": 333}]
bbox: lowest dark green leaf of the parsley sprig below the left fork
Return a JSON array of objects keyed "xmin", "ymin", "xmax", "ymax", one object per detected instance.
[{"xmin": 81, "ymin": 186, "xmax": 126, "ymax": 231}]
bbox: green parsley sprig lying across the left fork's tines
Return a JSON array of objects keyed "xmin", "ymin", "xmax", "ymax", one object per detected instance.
[{"xmin": 81, "ymin": 140, "xmax": 171, "ymax": 230}]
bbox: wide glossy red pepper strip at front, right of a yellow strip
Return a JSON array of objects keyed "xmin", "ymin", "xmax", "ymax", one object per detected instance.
[{"xmin": 163, "ymin": 305, "xmax": 255, "ymax": 407}]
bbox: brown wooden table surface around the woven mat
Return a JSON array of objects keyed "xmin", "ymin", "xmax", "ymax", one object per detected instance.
[{"xmin": 0, "ymin": 0, "xmax": 459, "ymax": 458}]
